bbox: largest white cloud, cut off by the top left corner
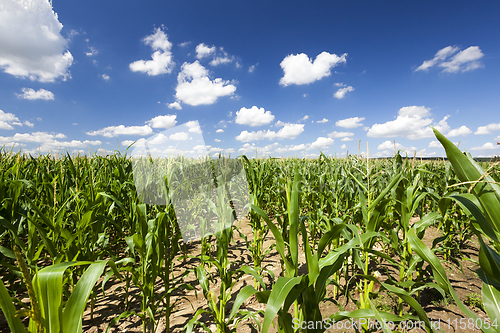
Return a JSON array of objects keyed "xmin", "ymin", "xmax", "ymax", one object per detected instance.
[{"xmin": 0, "ymin": 0, "xmax": 73, "ymax": 82}]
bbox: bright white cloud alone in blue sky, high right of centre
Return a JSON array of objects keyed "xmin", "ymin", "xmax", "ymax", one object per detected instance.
[{"xmin": 280, "ymin": 52, "xmax": 347, "ymax": 86}]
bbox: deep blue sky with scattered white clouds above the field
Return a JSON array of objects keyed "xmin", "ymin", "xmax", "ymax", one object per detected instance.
[{"xmin": 0, "ymin": 0, "xmax": 500, "ymax": 157}]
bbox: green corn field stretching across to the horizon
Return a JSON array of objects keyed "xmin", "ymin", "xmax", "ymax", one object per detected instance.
[{"xmin": 0, "ymin": 130, "xmax": 500, "ymax": 333}]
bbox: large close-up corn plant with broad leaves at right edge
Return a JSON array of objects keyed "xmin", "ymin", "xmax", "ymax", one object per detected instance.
[{"xmin": 428, "ymin": 129, "xmax": 500, "ymax": 332}]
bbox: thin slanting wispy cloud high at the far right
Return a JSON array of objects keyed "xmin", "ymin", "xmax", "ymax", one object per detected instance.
[{"xmin": 415, "ymin": 46, "xmax": 484, "ymax": 73}]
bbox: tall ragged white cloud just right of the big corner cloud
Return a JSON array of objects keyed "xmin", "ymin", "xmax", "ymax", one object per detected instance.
[{"xmin": 129, "ymin": 27, "xmax": 175, "ymax": 76}]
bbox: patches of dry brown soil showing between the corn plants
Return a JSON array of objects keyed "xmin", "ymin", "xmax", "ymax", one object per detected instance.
[{"xmin": 0, "ymin": 218, "xmax": 487, "ymax": 333}]
